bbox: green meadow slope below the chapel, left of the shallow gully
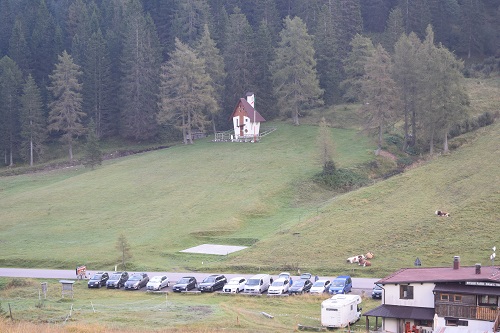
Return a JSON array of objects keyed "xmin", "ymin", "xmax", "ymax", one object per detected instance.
[{"xmin": 0, "ymin": 120, "xmax": 373, "ymax": 269}]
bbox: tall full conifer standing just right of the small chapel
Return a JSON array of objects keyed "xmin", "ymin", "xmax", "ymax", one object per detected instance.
[{"xmin": 271, "ymin": 17, "xmax": 323, "ymax": 125}]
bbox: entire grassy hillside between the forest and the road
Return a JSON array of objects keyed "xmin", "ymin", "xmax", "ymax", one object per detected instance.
[{"xmin": 0, "ymin": 76, "xmax": 500, "ymax": 277}]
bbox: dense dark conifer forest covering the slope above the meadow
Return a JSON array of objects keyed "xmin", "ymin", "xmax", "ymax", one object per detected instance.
[{"xmin": 0, "ymin": 0, "xmax": 500, "ymax": 165}]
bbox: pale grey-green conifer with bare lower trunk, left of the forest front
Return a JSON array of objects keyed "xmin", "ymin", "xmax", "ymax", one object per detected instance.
[{"xmin": 48, "ymin": 51, "xmax": 85, "ymax": 161}]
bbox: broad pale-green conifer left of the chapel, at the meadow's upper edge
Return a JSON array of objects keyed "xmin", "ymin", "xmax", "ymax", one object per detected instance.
[{"xmin": 157, "ymin": 40, "xmax": 217, "ymax": 144}]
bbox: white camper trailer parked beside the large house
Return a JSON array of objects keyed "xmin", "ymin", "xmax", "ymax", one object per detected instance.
[{"xmin": 321, "ymin": 294, "xmax": 361, "ymax": 327}]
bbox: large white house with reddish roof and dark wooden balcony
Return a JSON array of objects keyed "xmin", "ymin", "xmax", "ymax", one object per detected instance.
[{"xmin": 364, "ymin": 256, "xmax": 500, "ymax": 333}]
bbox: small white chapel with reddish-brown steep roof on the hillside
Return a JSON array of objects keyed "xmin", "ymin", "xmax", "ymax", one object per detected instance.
[{"xmin": 231, "ymin": 92, "xmax": 266, "ymax": 142}]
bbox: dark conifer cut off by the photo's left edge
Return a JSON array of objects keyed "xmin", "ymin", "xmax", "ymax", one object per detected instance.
[{"xmin": 0, "ymin": 56, "xmax": 22, "ymax": 166}]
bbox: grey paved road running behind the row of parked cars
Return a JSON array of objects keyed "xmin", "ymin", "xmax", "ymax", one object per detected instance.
[{"xmin": 0, "ymin": 268, "xmax": 379, "ymax": 291}]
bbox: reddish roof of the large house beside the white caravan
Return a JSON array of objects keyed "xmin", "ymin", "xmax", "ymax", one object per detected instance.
[{"xmin": 376, "ymin": 266, "xmax": 500, "ymax": 284}]
